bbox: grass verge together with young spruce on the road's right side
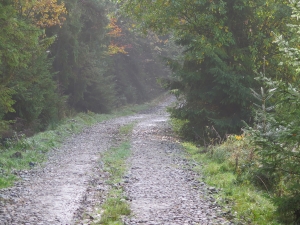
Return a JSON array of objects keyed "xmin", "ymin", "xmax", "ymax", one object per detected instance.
[{"xmin": 172, "ymin": 64, "xmax": 300, "ymax": 225}]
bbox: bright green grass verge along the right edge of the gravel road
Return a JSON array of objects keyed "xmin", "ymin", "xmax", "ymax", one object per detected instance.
[{"xmin": 182, "ymin": 142, "xmax": 279, "ymax": 225}]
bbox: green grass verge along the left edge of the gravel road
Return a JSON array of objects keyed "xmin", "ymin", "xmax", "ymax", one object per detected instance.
[{"xmin": 0, "ymin": 96, "xmax": 164, "ymax": 189}]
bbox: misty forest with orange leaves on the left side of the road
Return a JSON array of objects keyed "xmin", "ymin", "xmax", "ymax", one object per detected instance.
[{"xmin": 0, "ymin": 0, "xmax": 168, "ymax": 138}]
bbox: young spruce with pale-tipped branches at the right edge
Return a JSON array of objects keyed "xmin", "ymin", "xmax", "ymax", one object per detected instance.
[{"xmin": 248, "ymin": 75, "xmax": 300, "ymax": 223}]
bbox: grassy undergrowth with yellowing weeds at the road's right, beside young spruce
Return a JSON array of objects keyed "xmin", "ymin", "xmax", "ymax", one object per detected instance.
[{"xmin": 183, "ymin": 139, "xmax": 280, "ymax": 225}]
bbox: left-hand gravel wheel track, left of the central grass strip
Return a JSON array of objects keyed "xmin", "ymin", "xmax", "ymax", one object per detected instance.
[{"xmin": 0, "ymin": 115, "xmax": 142, "ymax": 225}]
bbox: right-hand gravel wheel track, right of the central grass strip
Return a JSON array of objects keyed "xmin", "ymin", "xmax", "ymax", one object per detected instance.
[{"xmin": 125, "ymin": 99, "xmax": 229, "ymax": 225}]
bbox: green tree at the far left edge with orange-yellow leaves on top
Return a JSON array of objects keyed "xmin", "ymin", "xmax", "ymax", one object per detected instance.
[{"xmin": 0, "ymin": 1, "xmax": 66, "ymax": 134}]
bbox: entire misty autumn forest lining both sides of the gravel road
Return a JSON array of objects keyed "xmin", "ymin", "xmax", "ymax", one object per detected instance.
[{"xmin": 0, "ymin": 0, "xmax": 300, "ymax": 224}]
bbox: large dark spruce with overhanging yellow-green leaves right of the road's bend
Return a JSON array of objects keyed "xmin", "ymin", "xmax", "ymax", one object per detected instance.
[{"xmin": 118, "ymin": 0, "xmax": 290, "ymax": 142}]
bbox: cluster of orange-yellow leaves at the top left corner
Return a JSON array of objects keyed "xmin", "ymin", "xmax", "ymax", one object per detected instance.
[{"xmin": 14, "ymin": 0, "xmax": 67, "ymax": 28}]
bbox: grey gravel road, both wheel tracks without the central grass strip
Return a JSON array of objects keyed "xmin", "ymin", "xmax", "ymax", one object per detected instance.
[{"xmin": 0, "ymin": 97, "xmax": 230, "ymax": 225}]
